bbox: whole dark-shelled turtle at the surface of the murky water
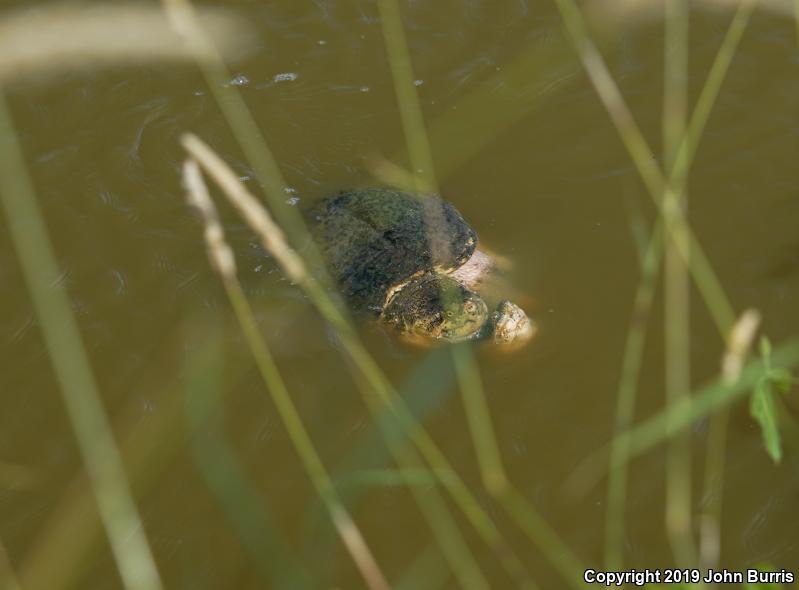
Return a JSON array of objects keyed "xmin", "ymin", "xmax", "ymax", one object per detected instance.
[{"xmin": 307, "ymin": 187, "xmax": 535, "ymax": 348}]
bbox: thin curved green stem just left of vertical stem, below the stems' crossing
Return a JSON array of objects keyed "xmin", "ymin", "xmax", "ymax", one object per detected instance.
[{"xmin": 605, "ymin": 222, "xmax": 663, "ymax": 571}]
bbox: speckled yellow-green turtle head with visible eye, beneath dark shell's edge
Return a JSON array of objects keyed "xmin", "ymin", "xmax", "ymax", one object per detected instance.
[{"xmin": 382, "ymin": 273, "xmax": 488, "ymax": 342}]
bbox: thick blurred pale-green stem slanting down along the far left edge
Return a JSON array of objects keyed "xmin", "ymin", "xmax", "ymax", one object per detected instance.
[{"xmin": 0, "ymin": 93, "xmax": 161, "ymax": 590}]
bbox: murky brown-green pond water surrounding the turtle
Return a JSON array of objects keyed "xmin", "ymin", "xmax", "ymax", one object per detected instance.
[{"xmin": 0, "ymin": 0, "xmax": 799, "ymax": 588}]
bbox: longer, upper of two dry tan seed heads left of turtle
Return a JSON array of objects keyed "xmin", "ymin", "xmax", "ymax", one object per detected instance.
[{"xmin": 181, "ymin": 133, "xmax": 307, "ymax": 283}]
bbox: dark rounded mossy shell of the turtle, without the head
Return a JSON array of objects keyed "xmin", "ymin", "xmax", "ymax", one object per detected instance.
[{"xmin": 309, "ymin": 188, "xmax": 477, "ymax": 313}]
